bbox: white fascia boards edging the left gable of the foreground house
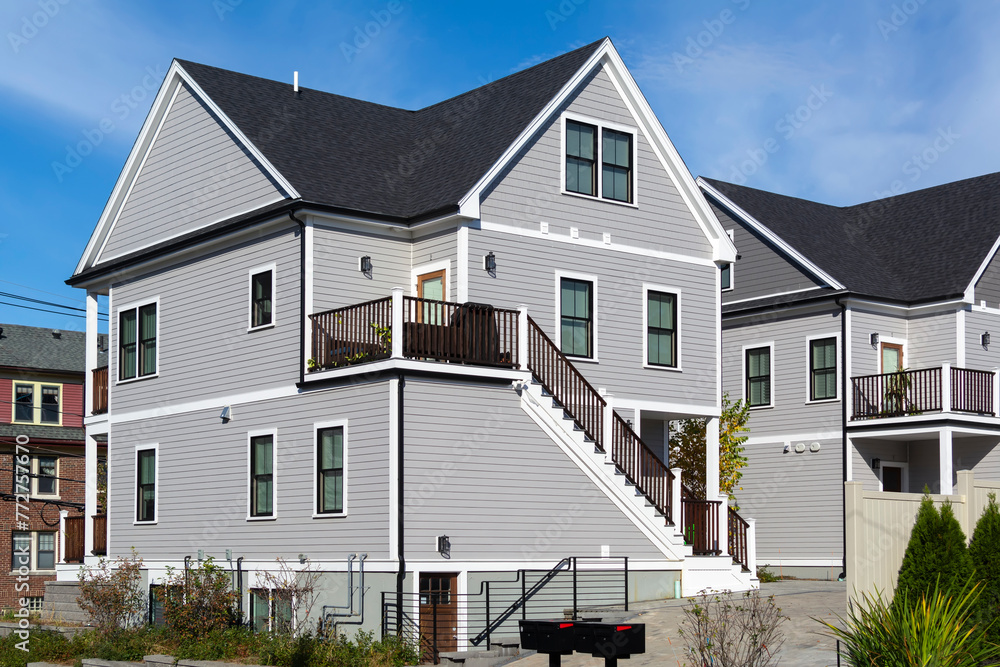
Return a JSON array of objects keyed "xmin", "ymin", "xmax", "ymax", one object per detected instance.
[{"xmin": 74, "ymin": 60, "xmax": 299, "ymax": 274}]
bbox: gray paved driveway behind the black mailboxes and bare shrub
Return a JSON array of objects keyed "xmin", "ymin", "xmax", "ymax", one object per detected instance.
[{"xmin": 510, "ymin": 581, "xmax": 847, "ymax": 667}]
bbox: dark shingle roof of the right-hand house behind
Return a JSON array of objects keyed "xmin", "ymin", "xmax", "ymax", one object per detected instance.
[{"xmin": 704, "ymin": 173, "xmax": 1000, "ymax": 303}]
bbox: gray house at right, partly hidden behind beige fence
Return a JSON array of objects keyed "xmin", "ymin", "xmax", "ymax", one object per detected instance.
[{"xmin": 698, "ymin": 174, "xmax": 1000, "ymax": 577}]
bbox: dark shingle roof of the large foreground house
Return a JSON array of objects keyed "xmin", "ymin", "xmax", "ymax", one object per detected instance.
[{"xmin": 178, "ymin": 40, "xmax": 604, "ymax": 219}]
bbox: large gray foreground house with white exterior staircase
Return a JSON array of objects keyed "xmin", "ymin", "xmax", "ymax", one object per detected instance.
[{"xmin": 65, "ymin": 39, "xmax": 756, "ymax": 646}]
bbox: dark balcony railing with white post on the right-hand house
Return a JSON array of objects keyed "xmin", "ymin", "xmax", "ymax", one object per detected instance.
[{"xmin": 851, "ymin": 364, "xmax": 998, "ymax": 421}]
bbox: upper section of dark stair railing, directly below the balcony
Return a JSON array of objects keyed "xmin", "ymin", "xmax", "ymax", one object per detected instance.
[{"xmin": 528, "ymin": 317, "xmax": 604, "ymax": 452}]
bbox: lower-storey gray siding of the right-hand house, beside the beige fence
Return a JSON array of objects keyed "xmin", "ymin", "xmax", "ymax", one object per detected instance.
[{"xmin": 736, "ymin": 438, "xmax": 843, "ymax": 563}]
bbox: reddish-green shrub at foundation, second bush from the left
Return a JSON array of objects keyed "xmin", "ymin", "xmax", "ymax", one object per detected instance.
[{"xmin": 161, "ymin": 557, "xmax": 241, "ymax": 639}]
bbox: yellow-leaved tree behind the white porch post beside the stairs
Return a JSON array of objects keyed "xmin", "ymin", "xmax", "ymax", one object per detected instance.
[{"xmin": 670, "ymin": 394, "xmax": 750, "ymax": 501}]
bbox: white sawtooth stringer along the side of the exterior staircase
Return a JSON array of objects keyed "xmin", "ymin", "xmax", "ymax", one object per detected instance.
[{"xmin": 516, "ymin": 382, "xmax": 691, "ymax": 564}]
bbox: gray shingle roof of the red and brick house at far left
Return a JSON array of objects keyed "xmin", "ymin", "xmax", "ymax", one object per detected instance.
[{"xmin": 0, "ymin": 324, "xmax": 86, "ymax": 373}]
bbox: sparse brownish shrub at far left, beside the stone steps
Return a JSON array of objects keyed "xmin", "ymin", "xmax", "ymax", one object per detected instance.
[{"xmin": 76, "ymin": 549, "xmax": 146, "ymax": 634}]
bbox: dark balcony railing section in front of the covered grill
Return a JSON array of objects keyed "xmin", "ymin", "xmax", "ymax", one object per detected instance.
[{"xmin": 403, "ymin": 296, "xmax": 520, "ymax": 368}]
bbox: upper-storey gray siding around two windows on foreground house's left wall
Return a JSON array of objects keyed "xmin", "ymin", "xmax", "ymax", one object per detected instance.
[{"xmin": 109, "ymin": 225, "xmax": 300, "ymax": 413}]
